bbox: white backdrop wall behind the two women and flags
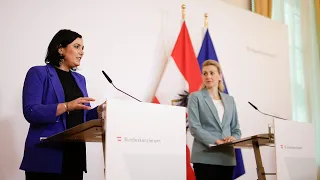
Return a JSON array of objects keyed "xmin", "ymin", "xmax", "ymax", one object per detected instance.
[{"xmin": 0, "ymin": 0, "xmax": 291, "ymax": 180}]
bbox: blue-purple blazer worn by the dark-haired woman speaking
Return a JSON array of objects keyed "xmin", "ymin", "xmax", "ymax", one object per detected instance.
[{"xmin": 20, "ymin": 65, "xmax": 98, "ymax": 173}]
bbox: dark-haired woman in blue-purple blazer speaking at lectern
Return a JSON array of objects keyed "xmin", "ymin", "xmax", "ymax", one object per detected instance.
[{"xmin": 20, "ymin": 30, "xmax": 102, "ymax": 180}]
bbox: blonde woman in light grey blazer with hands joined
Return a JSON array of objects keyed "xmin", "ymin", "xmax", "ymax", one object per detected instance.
[{"xmin": 188, "ymin": 60, "xmax": 241, "ymax": 180}]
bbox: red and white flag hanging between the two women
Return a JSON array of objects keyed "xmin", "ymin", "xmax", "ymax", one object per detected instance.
[{"xmin": 153, "ymin": 21, "xmax": 201, "ymax": 180}]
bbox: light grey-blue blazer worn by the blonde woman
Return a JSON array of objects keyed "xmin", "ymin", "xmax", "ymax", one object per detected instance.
[{"xmin": 188, "ymin": 89, "xmax": 241, "ymax": 166}]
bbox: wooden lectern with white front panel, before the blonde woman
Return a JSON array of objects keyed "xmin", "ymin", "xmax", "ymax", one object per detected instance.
[{"xmin": 212, "ymin": 118, "xmax": 317, "ymax": 180}]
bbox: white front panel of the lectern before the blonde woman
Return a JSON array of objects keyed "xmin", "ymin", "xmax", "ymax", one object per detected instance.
[{"xmin": 274, "ymin": 119, "xmax": 317, "ymax": 180}]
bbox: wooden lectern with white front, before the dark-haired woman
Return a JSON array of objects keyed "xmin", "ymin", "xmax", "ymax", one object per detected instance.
[{"xmin": 41, "ymin": 99, "xmax": 186, "ymax": 180}]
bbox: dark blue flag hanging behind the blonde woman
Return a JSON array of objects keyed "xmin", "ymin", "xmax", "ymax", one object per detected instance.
[{"xmin": 198, "ymin": 29, "xmax": 245, "ymax": 179}]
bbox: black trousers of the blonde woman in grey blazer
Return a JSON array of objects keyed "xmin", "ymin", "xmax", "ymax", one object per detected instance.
[{"xmin": 193, "ymin": 163, "xmax": 234, "ymax": 180}]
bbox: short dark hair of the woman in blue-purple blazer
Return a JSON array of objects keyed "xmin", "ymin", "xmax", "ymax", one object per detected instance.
[{"xmin": 45, "ymin": 29, "xmax": 82, "ymax": 67}]
